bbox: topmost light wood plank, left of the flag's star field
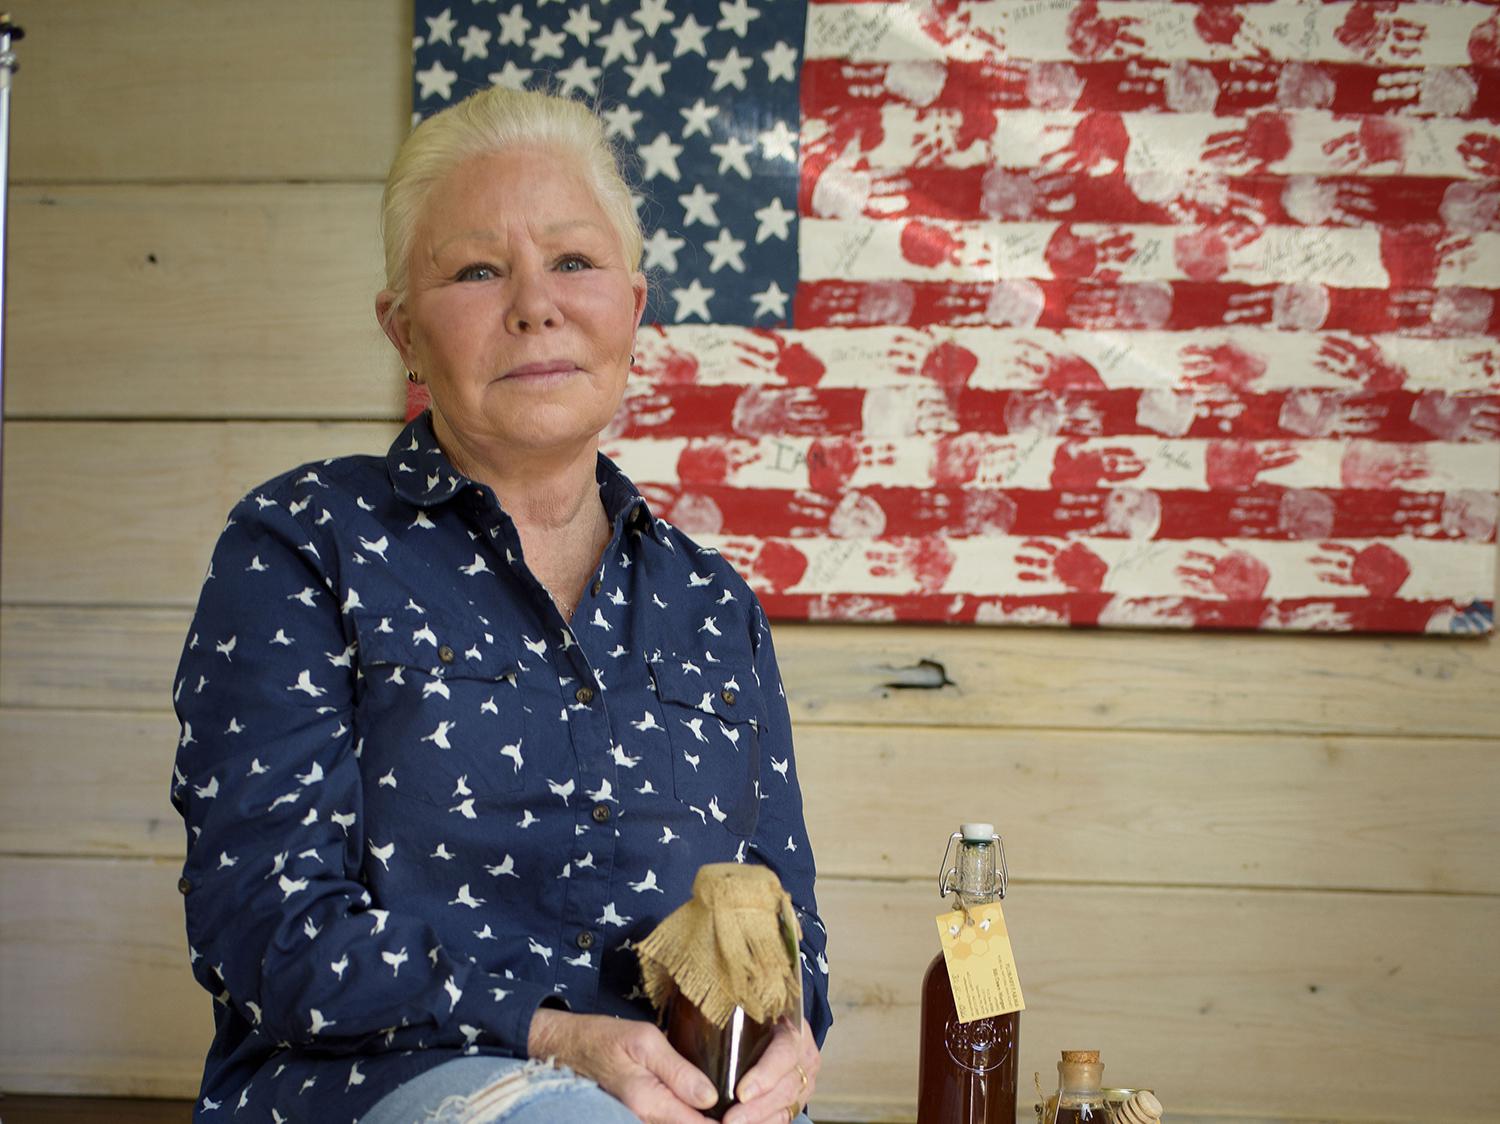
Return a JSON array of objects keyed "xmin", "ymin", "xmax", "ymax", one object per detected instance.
[{"xmin": 9, "ymin": 0, "xmax": 411, "ymax": 183}]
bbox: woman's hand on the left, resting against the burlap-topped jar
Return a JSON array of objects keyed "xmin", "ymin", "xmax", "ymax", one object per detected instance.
[{"xmin": 527, "ymin": 1007, "xmax": 720, "ymax": 1124}]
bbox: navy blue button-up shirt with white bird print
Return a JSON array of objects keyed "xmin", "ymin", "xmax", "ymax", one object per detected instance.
[{"xmin": 171, "ymin": 416, "xmax": 831, "ymax": 1122}]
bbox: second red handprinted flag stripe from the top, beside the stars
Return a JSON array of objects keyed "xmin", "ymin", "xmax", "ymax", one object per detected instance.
[{"xmin": 803, "ymin": 165, "xmax": 1500, "ymax": 234}]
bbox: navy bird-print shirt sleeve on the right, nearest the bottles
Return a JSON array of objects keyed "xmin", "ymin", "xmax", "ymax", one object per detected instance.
[{"xmin": 750, "ymin": 602, "xmax": 833, "ymax": 1047}]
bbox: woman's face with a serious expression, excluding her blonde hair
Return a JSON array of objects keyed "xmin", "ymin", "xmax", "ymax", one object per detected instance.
[{"xmin": 377, "ymin": 147, "xmax": 647, "ymax": 462}]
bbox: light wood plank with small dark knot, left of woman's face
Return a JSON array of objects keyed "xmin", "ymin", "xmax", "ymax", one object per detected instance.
[{"xmin": 6, "ymin": 186, "xmax": 405, "ymax": 419}]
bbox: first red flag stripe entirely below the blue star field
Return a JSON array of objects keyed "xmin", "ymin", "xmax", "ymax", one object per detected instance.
[{"xmin": 615, "ymin": 387, "xmax": 1500, "ymax": 444}]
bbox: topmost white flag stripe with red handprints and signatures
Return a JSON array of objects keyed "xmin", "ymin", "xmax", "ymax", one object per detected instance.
[{"xmin": 807, "ymin": 0, "xmax": 1493, "ymax": 66}]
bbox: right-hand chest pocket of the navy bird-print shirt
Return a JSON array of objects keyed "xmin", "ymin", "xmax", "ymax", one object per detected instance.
[{"xmin": 650, "ymin": 656, "xmax": 765, "ymax": 837}]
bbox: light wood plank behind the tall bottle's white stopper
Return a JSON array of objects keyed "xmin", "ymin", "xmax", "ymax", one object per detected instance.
[{"xmin": 0, "ymin": 711, "xmax": 1500, "ymax": 893}]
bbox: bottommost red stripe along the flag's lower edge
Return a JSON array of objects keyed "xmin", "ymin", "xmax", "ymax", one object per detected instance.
[{"xmin": 752, "ymin": 582, "xmax": 1476, "ymax": 632}]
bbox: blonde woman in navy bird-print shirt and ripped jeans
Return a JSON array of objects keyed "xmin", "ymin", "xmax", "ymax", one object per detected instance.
[{"xmin": 173, "ymin": 90, "xmax": 830, "ymax": 1124}]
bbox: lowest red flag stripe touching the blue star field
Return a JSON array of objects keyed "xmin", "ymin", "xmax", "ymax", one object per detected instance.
[{"xmin": 794, "ymin": 279, "xmax": 1500, "ymax": 338}]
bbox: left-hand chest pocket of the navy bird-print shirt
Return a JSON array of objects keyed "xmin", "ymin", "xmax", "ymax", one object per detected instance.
[{"xmin": 356, "ymin": 611, "xmax": 537, "ymax": 809}]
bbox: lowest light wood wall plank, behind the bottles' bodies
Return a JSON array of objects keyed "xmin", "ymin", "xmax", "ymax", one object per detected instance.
[{"xmin": 0, "ymin": 858, "xmax": 1500, "ymax": 1121}]
